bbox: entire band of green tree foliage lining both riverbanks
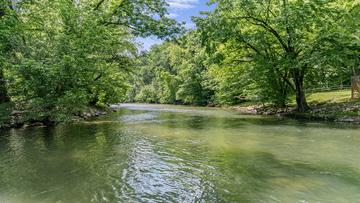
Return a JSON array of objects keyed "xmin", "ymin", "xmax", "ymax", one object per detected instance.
[{"xmin": 0, "ymin": 0, "xmax": 360, "ymax": 127}]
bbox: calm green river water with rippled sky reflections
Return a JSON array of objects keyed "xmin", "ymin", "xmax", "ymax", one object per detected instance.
[{"xmin": 0, "ymin": 105, "xmax": 360, "ymax": 203}]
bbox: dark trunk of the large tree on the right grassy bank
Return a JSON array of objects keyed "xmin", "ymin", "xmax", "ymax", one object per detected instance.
[{"xmin": 293, "ymin": 70, "xmax": 309, "ymax": 112}]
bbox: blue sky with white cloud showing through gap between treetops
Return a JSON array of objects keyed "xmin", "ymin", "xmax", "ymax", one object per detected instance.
[{"xmin": 137, "ymin": 0, "xmax": 211, "ymax": 50}]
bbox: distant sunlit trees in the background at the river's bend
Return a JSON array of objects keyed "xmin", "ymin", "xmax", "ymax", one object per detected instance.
[{"xmin": 128, "ymin": 32, "xmax": 213, "ymax": 105}]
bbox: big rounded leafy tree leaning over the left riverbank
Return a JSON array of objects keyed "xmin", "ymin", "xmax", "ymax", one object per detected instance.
[{"xmin": 1, "ymin": 1, "xmax": 135, "ymax": 120}]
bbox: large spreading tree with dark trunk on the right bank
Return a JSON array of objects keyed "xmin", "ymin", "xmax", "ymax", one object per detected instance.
[{"xmin": 196, "ymin": 0, "xmax": 356, "ymax": 112}]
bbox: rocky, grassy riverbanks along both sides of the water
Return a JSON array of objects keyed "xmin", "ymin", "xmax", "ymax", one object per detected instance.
[{"xmin": 0, "ymin": 90, "xmax": 360, "ymax": 129}]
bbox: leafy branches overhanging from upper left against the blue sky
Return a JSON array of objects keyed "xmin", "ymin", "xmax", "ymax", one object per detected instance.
[{"xmin": 94, "ymin": 0, "xmax": 183, "ymax": 39}]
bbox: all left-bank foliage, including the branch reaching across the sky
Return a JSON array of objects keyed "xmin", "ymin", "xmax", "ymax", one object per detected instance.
[{"xmin": 0, "ymin": 0, "xmax": 181, "ymax": 125}]
